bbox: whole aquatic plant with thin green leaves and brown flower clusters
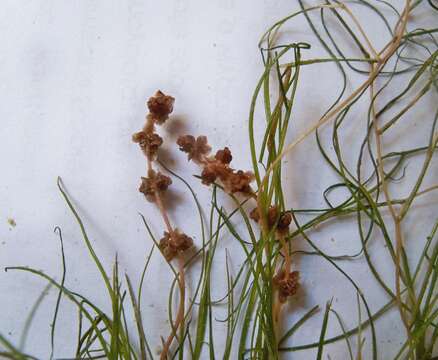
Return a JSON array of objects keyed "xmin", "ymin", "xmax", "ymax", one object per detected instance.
[{"xmin": 0, "ymin": 0, "xmax": 438, "ymax": 360}]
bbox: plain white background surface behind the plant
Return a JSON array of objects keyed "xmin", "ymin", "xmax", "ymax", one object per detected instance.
[{"xmin": 0, "ymin": 0, "xmax": 438, "ymax": 359}]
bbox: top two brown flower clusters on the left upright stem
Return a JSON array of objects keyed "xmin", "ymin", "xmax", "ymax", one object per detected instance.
[{"xmin": 132, "ymin": 90, "xmax": 175, "ymax": 161}]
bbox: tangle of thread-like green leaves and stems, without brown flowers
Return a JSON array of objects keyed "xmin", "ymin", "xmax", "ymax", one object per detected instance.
[{"xmin": 0, "ymin": 0, "xmax": 438, "ymax": 360}]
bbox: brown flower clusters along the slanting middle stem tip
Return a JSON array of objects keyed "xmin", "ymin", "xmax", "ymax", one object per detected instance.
[{"xmin": 177, "ymin": 135, "xmax": 254, "ymax": 196}]
